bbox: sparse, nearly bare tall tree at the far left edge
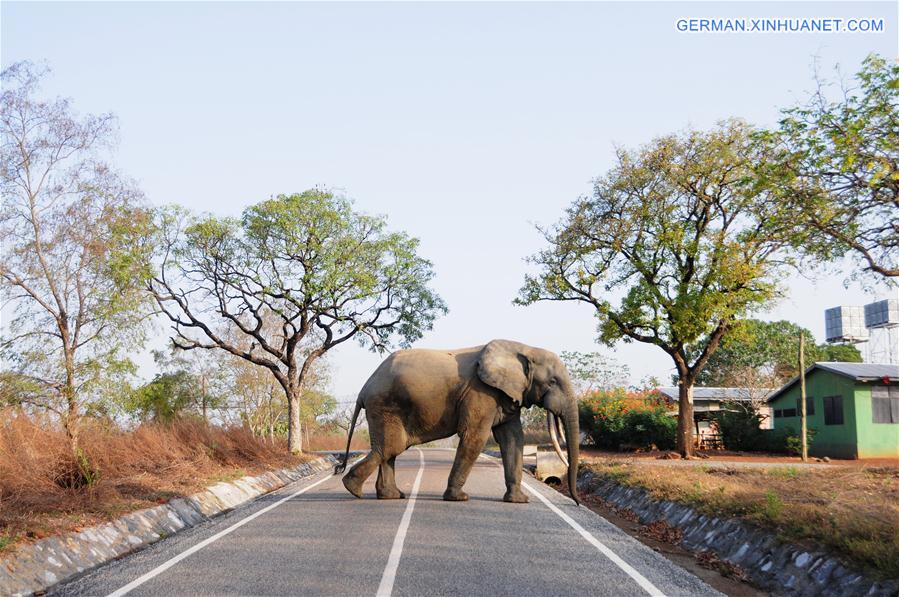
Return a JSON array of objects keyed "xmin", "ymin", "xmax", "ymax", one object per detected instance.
[{"xmin": 0, "ymin": 62, "xmax": 152, "ymax": 441}]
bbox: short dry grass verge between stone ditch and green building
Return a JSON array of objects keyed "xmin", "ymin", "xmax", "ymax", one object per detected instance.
[{"xmin": 587, "ymin": 460, "xmax": 899, "ymax": 578}]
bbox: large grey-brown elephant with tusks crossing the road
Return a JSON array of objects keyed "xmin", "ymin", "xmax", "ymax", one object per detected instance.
[{"xmin": 335, "ymin": 340, "xmax": 579, "ymax": 503}]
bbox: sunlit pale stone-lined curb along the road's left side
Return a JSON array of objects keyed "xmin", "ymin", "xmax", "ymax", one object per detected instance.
[{"xmin": 0, "ymin": 454, "xmax": 338, "ymax": 596}]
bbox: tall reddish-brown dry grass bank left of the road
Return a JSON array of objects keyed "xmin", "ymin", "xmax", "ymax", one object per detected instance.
[{"xmin": 0, "ymin": 410, "xmax": 308, "ymax": 551}]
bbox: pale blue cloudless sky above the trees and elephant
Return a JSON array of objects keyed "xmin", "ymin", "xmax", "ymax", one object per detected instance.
[{"xmin": 0, "ymin": 2, "xmax": 897, "ymax": 397}]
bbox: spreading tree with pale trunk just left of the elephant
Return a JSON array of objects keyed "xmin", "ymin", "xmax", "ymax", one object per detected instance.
[{"xmin": 149, "ymin": 190, "xmax": 446, "ymax": 452}]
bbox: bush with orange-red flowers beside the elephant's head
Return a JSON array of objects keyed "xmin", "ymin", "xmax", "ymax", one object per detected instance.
[{"xmin": 578, "ymin": 388, "xmax": 677, "ymax": 450}]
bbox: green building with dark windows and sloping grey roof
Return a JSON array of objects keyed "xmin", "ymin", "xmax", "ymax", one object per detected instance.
[{"xmin": 768, "ymin": 363, "xmax": 899, "ymax": 458}]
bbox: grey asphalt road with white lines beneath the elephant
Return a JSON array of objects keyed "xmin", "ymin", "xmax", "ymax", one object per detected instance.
[{"xmin": 53, "ymin": 448, "xmax": 719, "ymax": 596}]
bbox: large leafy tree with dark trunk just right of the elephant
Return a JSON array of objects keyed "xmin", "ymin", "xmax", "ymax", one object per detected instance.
[{"xmin": 517, "ymin": 121, "xmax": 785, "ymax": 456}]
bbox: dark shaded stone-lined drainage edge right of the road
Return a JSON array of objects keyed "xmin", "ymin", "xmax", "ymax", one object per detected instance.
[{"xmin": 578, "ymin": 471, "xmax": 899, "ymax": 597}]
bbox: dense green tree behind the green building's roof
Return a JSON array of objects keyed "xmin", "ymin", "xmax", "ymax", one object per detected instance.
[{"xmin": 696, "ymin": 319, "xmax": 862, "ymax": 388}]
